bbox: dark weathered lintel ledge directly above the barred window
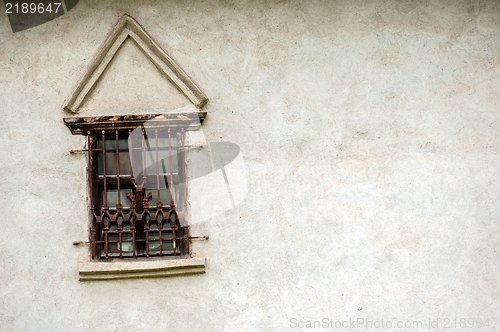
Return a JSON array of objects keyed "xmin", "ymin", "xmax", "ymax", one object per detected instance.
[{"xmin": 63, "ymin": 111, "xmax": 207, "ymax": 135}]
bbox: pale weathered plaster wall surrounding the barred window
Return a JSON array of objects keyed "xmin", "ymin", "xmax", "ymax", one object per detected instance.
[{"xmin": 0, "ymin": 0, "xmax": 500, "ymax": 331}]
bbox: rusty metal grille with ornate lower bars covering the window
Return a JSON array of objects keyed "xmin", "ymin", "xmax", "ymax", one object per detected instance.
[{"xmin": 87, "ymin": 128, "xmax": 190, "ymax": 259}]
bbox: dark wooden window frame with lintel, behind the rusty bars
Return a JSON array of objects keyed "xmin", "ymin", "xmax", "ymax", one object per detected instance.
[{"xmin": 64, "ymin": 111, "xmax": 206, "ymax": 261}]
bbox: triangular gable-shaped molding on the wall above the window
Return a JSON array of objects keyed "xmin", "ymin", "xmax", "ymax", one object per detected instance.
[{"xmin": 64, "ymin": 14, "xmax": 208, "ymax": 114}]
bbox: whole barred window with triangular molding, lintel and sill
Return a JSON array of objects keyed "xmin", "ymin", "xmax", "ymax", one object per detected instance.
[{"xmin": 64, "ymin": 15, "xmax": 208, "ymax": 274}]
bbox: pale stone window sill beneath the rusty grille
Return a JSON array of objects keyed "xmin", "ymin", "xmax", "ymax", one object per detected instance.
[{"xmin": 78, "ymin": 257, "xmax": 205, "ymax": 281}]
